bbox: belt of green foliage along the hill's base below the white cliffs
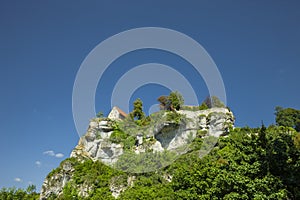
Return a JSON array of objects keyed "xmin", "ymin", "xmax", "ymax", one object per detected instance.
[{"xmin": 37, "ymin": 126, "xmax": 300, "ymax": 200}]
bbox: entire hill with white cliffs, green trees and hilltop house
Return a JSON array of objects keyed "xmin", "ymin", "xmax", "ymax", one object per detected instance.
[{"xmin": 0, "ymin": 93, "xmax": 300, "ymax": 200}]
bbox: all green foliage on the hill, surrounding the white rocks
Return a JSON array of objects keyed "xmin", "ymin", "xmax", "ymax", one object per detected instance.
[{"xmin": 0, "ymin": 102, "xmax": 300, "ymax": 200}]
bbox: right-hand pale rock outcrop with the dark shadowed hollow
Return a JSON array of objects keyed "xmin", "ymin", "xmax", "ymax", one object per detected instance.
[{"xmin": 153, "ymin": 108, "xmax": 234, "ymax": 153}]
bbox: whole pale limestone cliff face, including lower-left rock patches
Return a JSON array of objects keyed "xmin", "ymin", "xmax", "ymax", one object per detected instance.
[{"xmin": 41, "ymin": 108, "xmax": 234, "ymax": 199}]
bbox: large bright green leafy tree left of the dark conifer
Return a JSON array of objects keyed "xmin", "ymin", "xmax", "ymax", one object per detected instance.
[{"xmin": 171, "ymin": 128, "xmax": 297, "ymax": 200}]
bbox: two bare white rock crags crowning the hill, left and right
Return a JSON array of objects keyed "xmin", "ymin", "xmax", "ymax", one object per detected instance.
[{"xmin": 71, "ymin": 108, "xmax": 234, "ymax": 165}]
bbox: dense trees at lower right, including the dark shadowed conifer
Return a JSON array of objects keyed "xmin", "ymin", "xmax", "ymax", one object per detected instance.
[{"xmin": 172, "ymin": 127, "xmax": 300, "ymax": 199}]
